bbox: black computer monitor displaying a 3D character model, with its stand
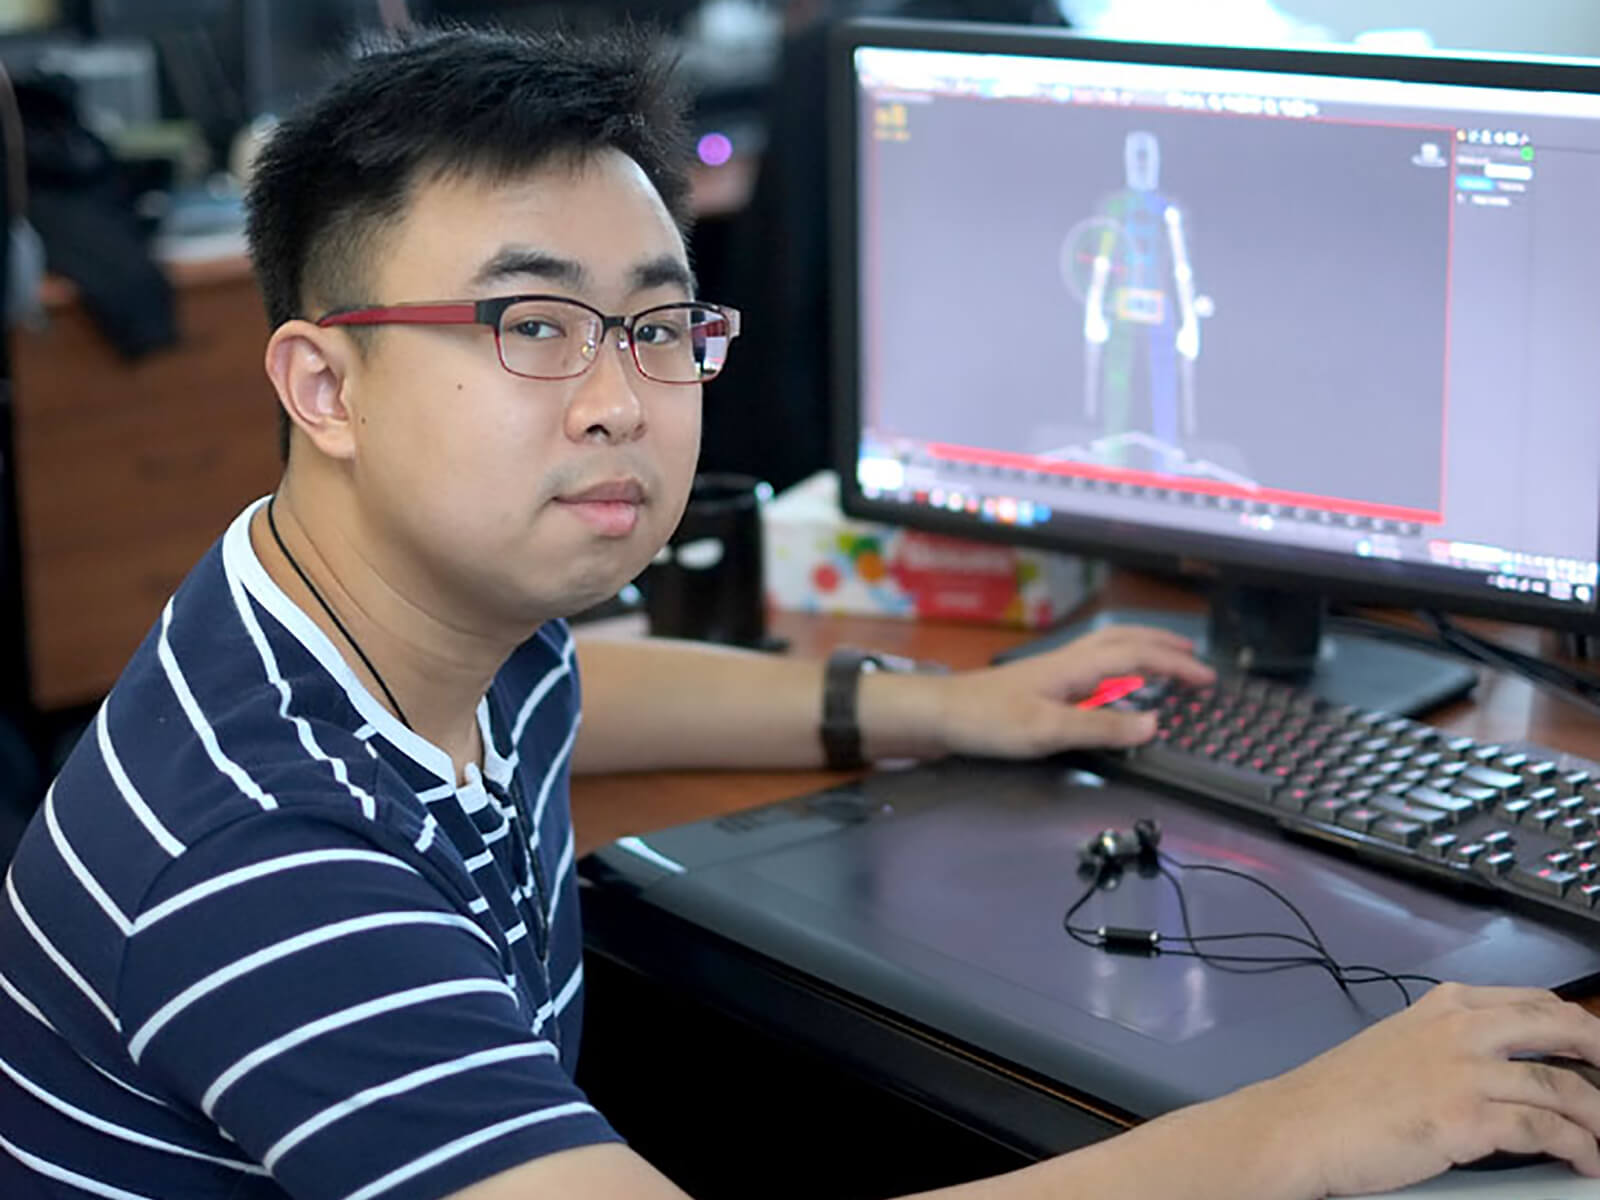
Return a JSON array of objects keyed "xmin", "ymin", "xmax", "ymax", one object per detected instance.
[{"xmin": 829, "ymin": 21, "xmax": 1600, "ymax": 710}]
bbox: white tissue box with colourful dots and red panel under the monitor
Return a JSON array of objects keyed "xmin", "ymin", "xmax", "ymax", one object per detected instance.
[{"xmin": 762, "ymin": 470, "xmax": 1101, "ymax": 629}]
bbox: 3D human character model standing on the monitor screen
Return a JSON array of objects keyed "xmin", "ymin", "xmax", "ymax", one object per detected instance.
[{"xmin": 1061, "ymin": 131, "xmax": 1211, "ymax": 459}]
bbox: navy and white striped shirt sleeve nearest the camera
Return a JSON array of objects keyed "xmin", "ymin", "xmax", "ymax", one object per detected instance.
[{"xmin": 117, "ymin": 810, "xmax": 618, "ymax": 1200}]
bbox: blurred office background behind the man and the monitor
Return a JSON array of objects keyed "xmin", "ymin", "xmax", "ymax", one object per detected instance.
[{"xmin": 0, "ymin": 0, "xmax": 1600, "ymax": 853}]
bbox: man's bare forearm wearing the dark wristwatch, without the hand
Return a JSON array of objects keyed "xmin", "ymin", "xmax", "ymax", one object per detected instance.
[{"xmin": 573, "ymin": 637, "xmax": 942, "ymax": 773}]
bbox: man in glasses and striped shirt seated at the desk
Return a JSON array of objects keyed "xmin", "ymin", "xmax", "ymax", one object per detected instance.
[{"xmin": 0, "ymin": 21, "xmax": 1600, "ymax": 1200}]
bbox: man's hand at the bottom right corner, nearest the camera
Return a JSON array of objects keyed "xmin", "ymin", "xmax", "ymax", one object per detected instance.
[{"xmin": 1230, "ymin": 984, "xmax": 1600, "ymax": 1195}]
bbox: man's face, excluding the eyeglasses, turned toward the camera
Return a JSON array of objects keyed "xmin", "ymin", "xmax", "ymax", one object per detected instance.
[{"xmin": 337, "ymin": 152, "xmax": 701, "ymax": 632}]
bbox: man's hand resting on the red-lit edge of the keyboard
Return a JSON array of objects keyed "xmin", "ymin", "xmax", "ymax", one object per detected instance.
[{"xmin": 908, "ymin": 626, "xmax": 1216, "ymax": 758}]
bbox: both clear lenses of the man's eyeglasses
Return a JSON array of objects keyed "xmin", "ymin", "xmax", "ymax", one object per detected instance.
[{"xmin": 499, "ymin": 299, "xmax": 730, "ymax": 384}]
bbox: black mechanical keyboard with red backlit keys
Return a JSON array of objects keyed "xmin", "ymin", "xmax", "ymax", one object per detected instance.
[{"xmin": 1098, "ymin": 678, "xmax": 1600, "ymax": 931}]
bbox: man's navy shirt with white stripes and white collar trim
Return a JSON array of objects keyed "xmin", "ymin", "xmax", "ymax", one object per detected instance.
[{"xmin": 0, "ymin": 502, "xmax": 616, "ymax": 1200}]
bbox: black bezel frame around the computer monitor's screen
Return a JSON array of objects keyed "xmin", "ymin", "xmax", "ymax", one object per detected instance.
[{"xmin": 827, "ymin": 18, "xmax": 1600, "ymax": 630}]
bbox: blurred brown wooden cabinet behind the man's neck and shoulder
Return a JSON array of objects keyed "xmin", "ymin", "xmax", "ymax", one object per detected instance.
[{"xmin": 14, "ymin": 259, "xmax": 278, "ymax": 710}]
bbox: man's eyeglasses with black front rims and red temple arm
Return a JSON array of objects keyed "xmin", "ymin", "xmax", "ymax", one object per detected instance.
[{"xmin": 317, "ymin": 296, "xmax": 739, "ymax": 384}]
